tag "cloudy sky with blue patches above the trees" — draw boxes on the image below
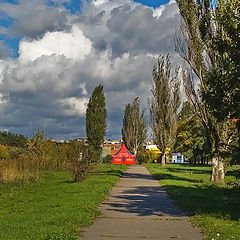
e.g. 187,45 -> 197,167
0,0 -> 179,139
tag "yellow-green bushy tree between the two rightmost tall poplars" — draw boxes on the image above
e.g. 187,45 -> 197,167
174,101 -> 210,161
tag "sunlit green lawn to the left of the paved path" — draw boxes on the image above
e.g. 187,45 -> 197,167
0,165 -> 126,240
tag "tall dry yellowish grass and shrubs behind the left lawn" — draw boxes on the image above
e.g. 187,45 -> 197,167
0,131 -> 90,183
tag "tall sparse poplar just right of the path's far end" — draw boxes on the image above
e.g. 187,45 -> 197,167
149,56 -> 180,165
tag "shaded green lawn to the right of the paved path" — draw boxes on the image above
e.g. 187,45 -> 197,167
146,164 -> 240,240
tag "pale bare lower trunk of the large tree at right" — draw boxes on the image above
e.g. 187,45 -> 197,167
211,157 -> 225,183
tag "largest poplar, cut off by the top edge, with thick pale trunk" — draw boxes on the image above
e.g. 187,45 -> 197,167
176,0 -> 240,182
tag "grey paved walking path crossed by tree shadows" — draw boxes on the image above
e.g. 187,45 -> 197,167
80,166 -> 203,240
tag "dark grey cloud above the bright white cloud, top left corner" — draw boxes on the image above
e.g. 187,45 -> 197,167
0,0 -> 69,38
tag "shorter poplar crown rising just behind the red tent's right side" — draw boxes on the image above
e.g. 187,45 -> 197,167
122,97 -> 147,155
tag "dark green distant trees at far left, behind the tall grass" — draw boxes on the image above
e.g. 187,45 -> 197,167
0,131 -> 27,148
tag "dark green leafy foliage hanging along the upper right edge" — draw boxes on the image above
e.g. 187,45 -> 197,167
201,0 -> 240,121
